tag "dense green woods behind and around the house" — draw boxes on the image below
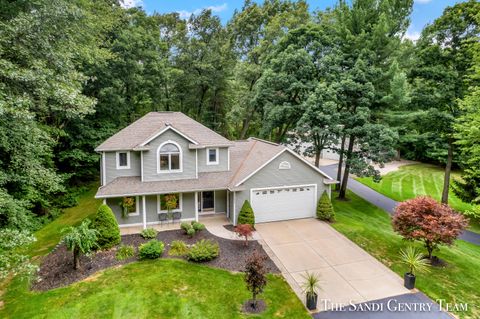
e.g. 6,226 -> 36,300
0,0 -> 480,230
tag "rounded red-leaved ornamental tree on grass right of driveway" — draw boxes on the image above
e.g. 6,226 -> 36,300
392,196 -> 468,259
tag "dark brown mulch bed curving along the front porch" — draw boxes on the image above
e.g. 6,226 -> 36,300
32,229 -> 280,291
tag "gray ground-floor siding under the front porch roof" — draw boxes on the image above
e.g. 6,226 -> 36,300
107,193 -> 195,226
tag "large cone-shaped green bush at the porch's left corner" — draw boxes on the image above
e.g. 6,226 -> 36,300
91,204 -> 120,249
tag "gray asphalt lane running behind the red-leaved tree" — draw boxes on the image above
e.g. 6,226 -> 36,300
320,164 -> 480,246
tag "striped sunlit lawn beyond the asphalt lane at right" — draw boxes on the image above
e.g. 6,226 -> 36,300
357,164 -> 480,233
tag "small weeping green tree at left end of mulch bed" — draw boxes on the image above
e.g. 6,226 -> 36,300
62,219 -> 98,269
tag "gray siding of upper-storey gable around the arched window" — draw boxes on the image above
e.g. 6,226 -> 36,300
143,130 -> 196,182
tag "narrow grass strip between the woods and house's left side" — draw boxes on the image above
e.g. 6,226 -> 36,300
27,183 -> 102,257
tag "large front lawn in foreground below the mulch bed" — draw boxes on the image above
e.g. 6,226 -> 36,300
0,259 -> 309,319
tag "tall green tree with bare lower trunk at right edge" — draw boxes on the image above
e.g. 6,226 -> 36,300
412,0 -> 480,203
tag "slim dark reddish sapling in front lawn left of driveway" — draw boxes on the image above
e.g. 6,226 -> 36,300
245,251 -> 267,309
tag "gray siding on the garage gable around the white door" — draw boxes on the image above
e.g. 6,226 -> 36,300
232,152 -> 330,225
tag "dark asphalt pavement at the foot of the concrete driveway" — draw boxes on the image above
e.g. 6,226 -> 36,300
312,292 -> 453,319
